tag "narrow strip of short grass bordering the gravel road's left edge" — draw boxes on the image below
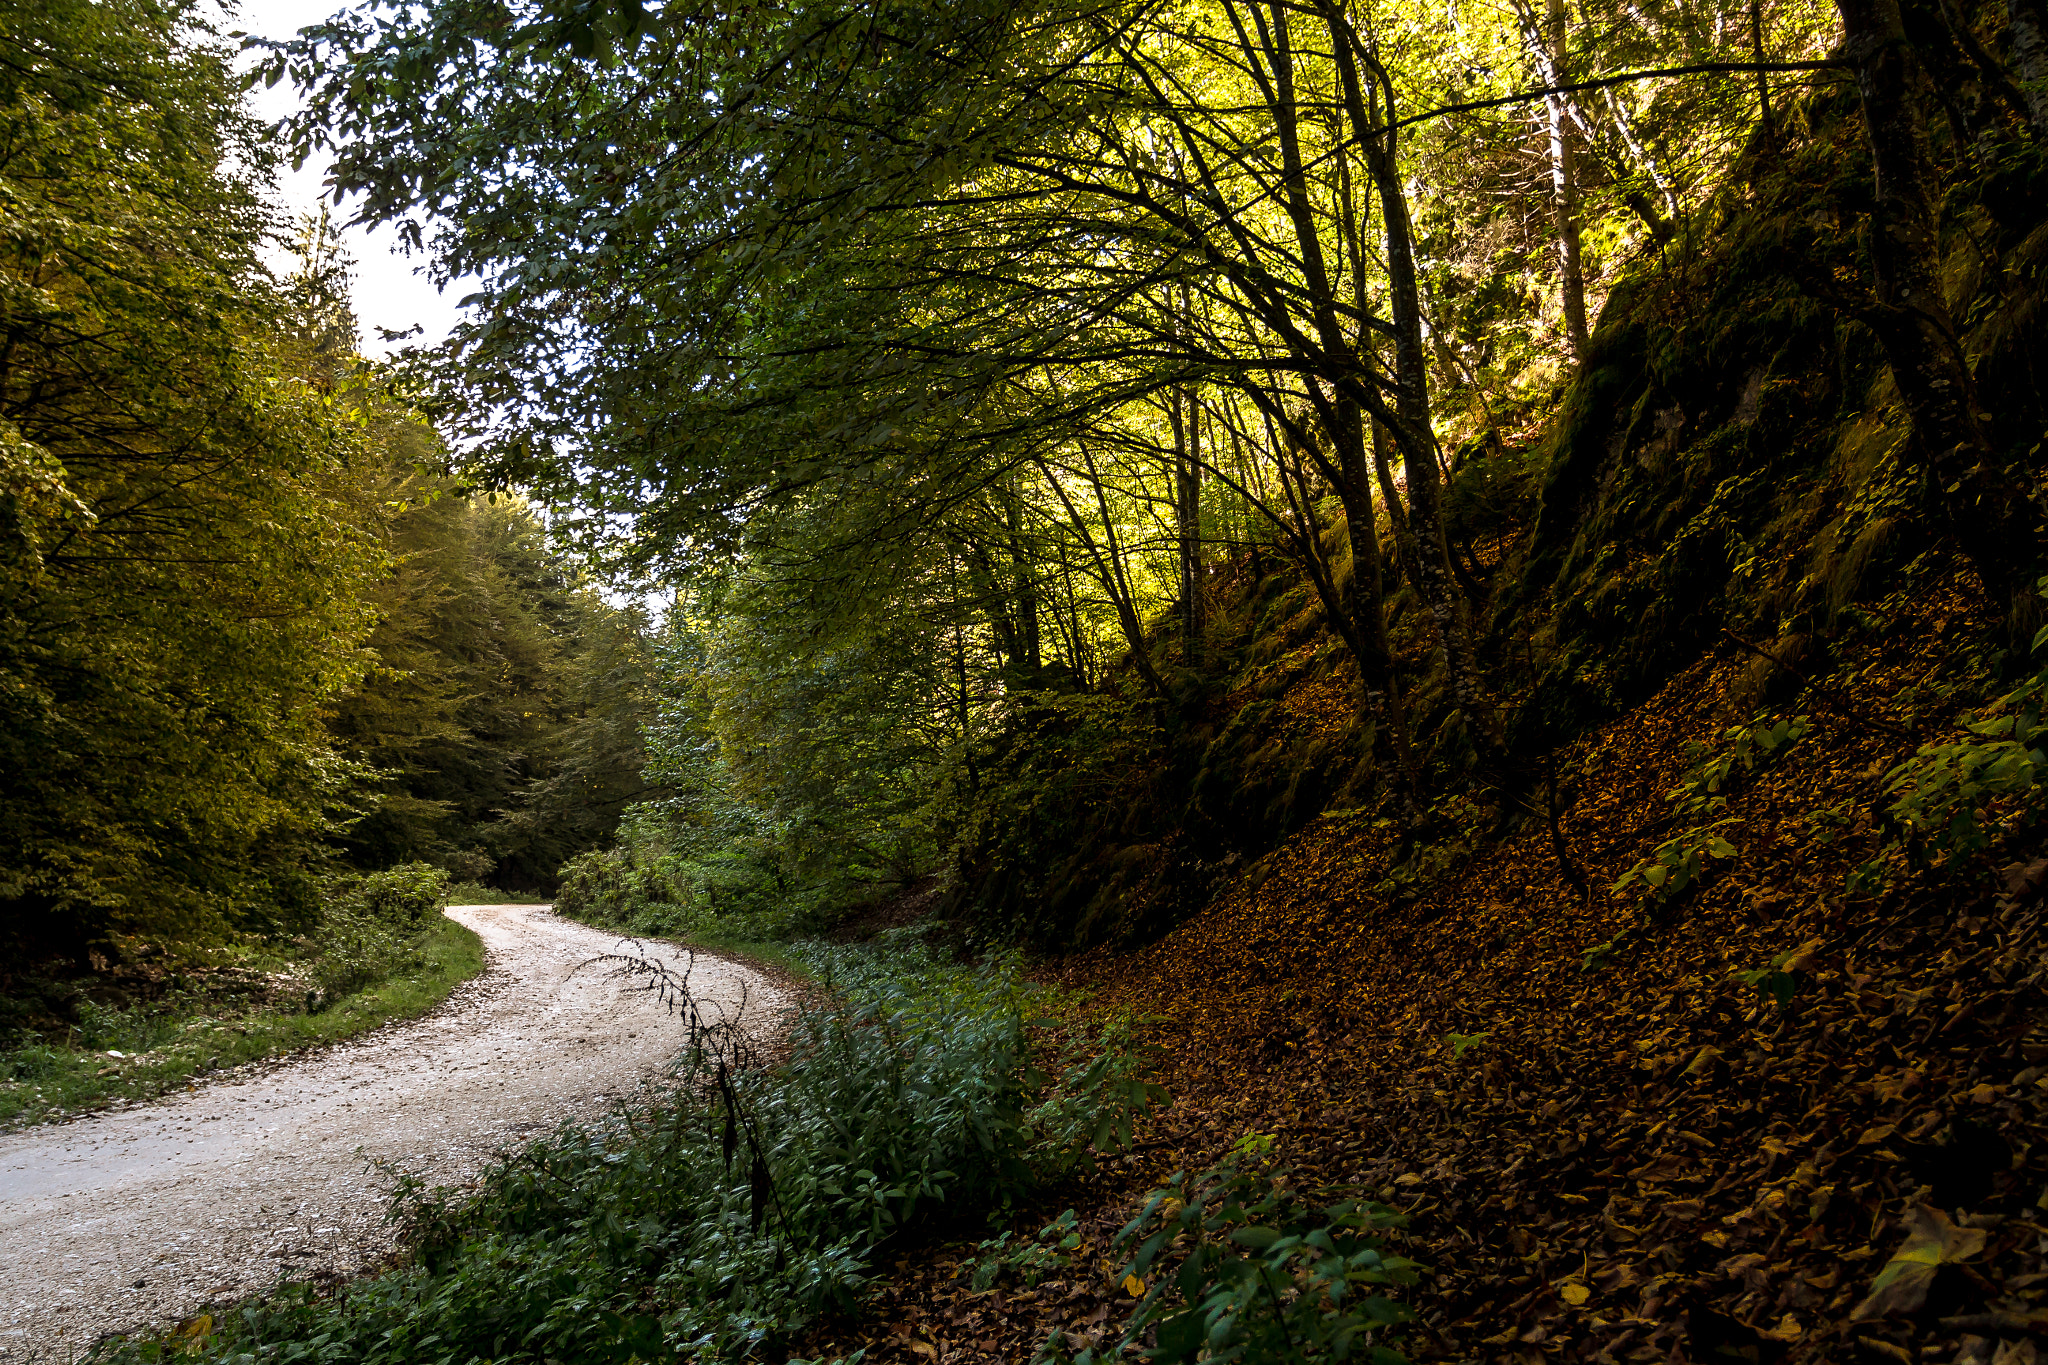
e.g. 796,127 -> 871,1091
0,919 -> 483,1130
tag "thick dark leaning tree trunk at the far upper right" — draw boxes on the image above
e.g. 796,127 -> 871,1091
1837,0 -> 2038,628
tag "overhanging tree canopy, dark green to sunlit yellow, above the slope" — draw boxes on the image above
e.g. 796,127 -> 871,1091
270,0 -> 1859,802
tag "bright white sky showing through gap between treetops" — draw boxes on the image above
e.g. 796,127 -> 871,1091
225,0 -> 469,356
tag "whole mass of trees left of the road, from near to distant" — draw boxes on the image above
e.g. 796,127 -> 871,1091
0,21 -> 655,965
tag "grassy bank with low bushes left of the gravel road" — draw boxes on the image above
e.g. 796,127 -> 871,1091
0,866 -> 483,1128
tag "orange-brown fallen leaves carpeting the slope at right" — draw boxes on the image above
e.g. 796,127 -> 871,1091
815,556 -> 2048,1365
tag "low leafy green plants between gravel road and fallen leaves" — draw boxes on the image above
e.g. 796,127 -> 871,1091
108,941 -> 1171,1361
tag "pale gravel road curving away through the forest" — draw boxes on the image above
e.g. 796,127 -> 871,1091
0,905 -> 782,1365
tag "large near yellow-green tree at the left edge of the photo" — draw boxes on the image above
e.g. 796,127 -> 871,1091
0,0 -> 383,960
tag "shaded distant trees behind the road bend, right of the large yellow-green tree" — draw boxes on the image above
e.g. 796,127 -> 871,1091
330,485 -> 653,888
